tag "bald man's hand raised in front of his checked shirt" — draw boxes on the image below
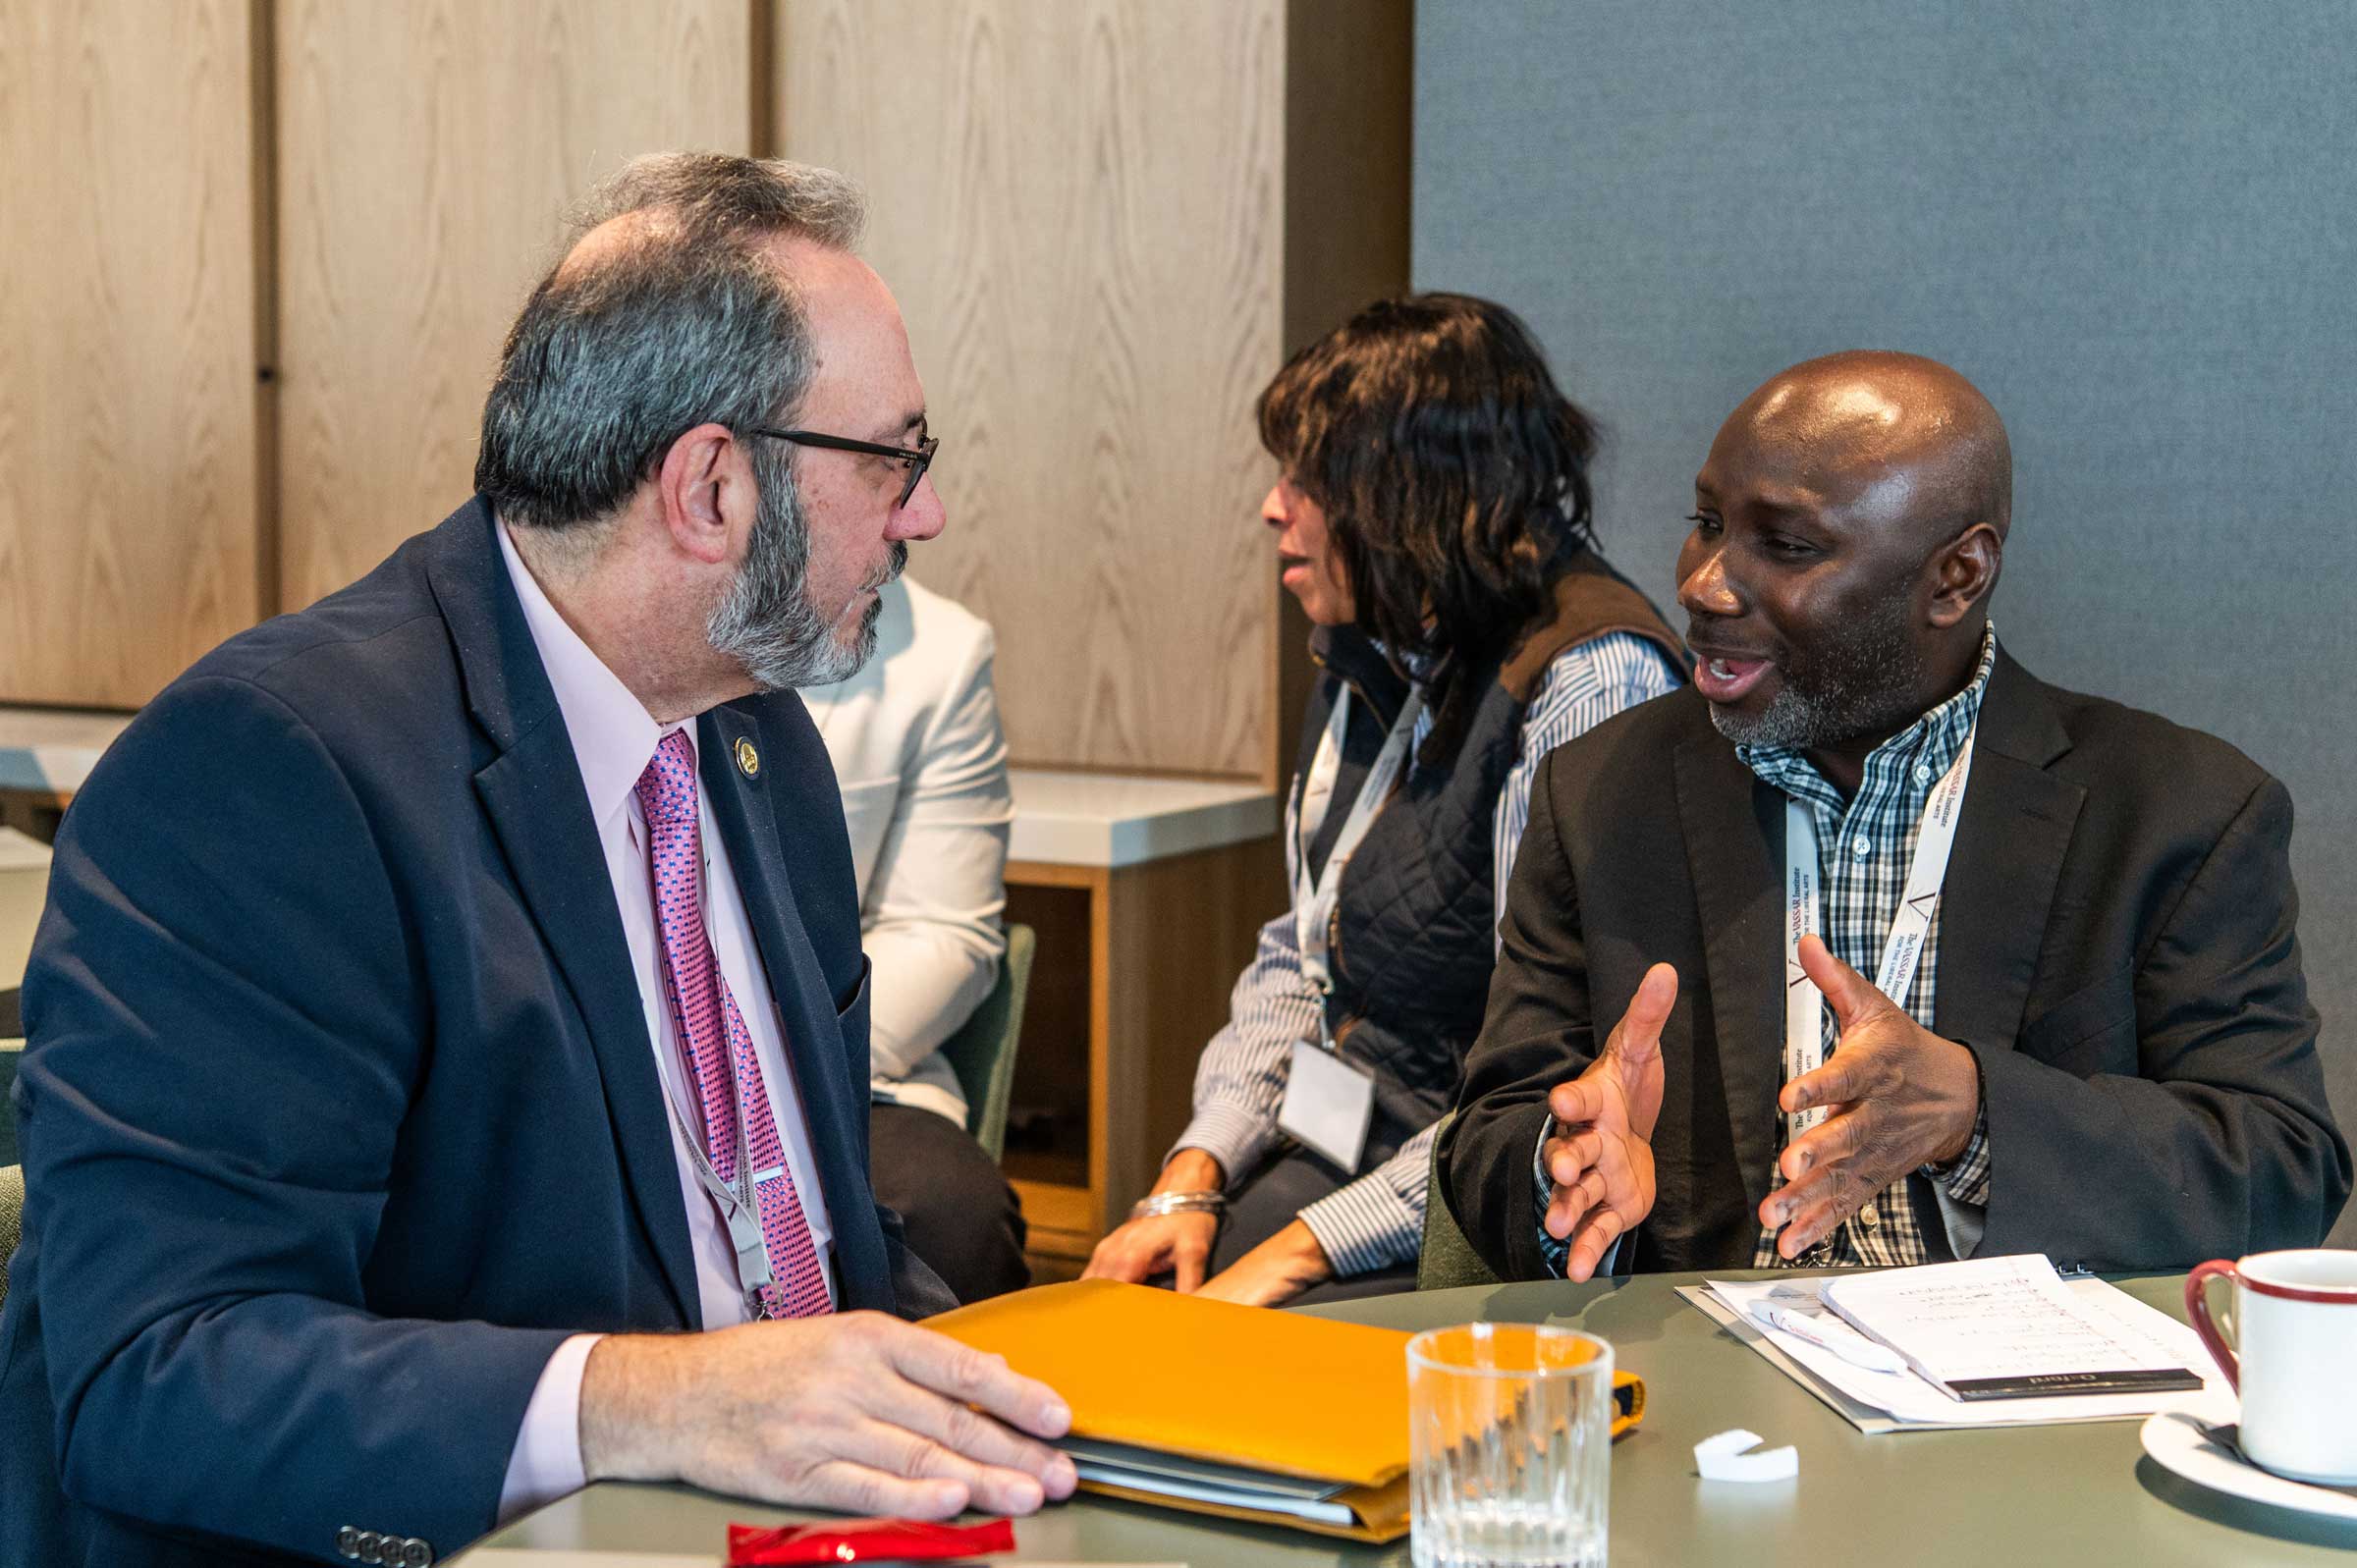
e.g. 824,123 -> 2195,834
1761,936 -> 1980,1257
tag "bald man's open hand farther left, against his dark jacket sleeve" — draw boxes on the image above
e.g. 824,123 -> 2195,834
1542,964 -> 1678,1280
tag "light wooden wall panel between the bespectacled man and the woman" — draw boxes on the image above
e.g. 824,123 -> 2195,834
776,0 -> 1285,778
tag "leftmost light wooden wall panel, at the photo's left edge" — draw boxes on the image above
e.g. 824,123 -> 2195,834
0,0 -> 257,707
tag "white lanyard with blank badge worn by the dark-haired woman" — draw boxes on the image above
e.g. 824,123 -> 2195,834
1278,686 -> 1424,1172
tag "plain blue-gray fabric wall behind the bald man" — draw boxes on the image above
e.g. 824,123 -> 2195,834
1414,0 -> 2357,1245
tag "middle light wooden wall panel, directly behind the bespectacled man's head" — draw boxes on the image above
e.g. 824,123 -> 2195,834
276,0 -> 756,609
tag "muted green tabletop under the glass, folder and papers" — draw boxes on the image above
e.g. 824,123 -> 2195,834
455,1275 -> 2357,1568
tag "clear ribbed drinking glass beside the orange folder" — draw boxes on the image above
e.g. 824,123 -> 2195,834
1407,1323 -> 1613,1568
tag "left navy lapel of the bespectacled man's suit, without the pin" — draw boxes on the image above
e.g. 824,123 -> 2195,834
426,495 -> 702,1327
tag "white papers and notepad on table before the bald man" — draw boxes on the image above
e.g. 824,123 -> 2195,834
1678,1255 -> 2234,1432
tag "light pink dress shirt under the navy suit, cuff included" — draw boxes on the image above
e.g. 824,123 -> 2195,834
500,523 -> 837,1523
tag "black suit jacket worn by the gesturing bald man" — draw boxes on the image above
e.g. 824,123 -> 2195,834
1440,651 -> 2350,1278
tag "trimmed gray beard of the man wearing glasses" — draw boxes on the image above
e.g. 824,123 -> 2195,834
705,474 -> 907,691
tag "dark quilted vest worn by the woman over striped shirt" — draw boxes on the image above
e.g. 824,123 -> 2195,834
1294,552 -> 1685,1167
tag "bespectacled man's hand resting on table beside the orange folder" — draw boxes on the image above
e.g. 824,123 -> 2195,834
579,1311 -> 1077,1519
